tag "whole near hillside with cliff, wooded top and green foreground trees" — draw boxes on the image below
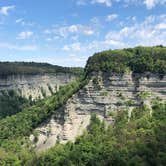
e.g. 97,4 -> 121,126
0,47 -> 166,166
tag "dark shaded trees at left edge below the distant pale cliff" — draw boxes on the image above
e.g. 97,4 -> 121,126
0,90 -> 34,119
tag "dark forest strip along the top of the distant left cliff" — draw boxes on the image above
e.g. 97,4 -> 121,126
0,62 -> 83,77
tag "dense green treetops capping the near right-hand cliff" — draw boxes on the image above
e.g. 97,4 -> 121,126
85,46 -> 166,74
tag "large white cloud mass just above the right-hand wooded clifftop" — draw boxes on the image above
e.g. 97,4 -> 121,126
105,16 -> 166,47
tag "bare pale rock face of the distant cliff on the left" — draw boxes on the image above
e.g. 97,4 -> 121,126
0,73 -> 76,99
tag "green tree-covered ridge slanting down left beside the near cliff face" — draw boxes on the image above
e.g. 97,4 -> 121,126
0,76 -> 86,144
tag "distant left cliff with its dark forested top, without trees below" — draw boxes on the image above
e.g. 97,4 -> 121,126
0,62 -> 82,99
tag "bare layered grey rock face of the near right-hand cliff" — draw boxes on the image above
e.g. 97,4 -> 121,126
30,73 -> 166,151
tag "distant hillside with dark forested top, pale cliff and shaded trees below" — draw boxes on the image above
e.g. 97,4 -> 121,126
0,62 -> 83,119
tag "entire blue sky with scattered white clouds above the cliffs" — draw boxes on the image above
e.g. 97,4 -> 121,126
0,0 -> 166,67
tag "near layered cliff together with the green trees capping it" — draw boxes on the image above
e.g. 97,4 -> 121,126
31,47 -> 166,151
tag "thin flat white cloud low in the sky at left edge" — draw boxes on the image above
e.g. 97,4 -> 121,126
0,43 -> 37,51
